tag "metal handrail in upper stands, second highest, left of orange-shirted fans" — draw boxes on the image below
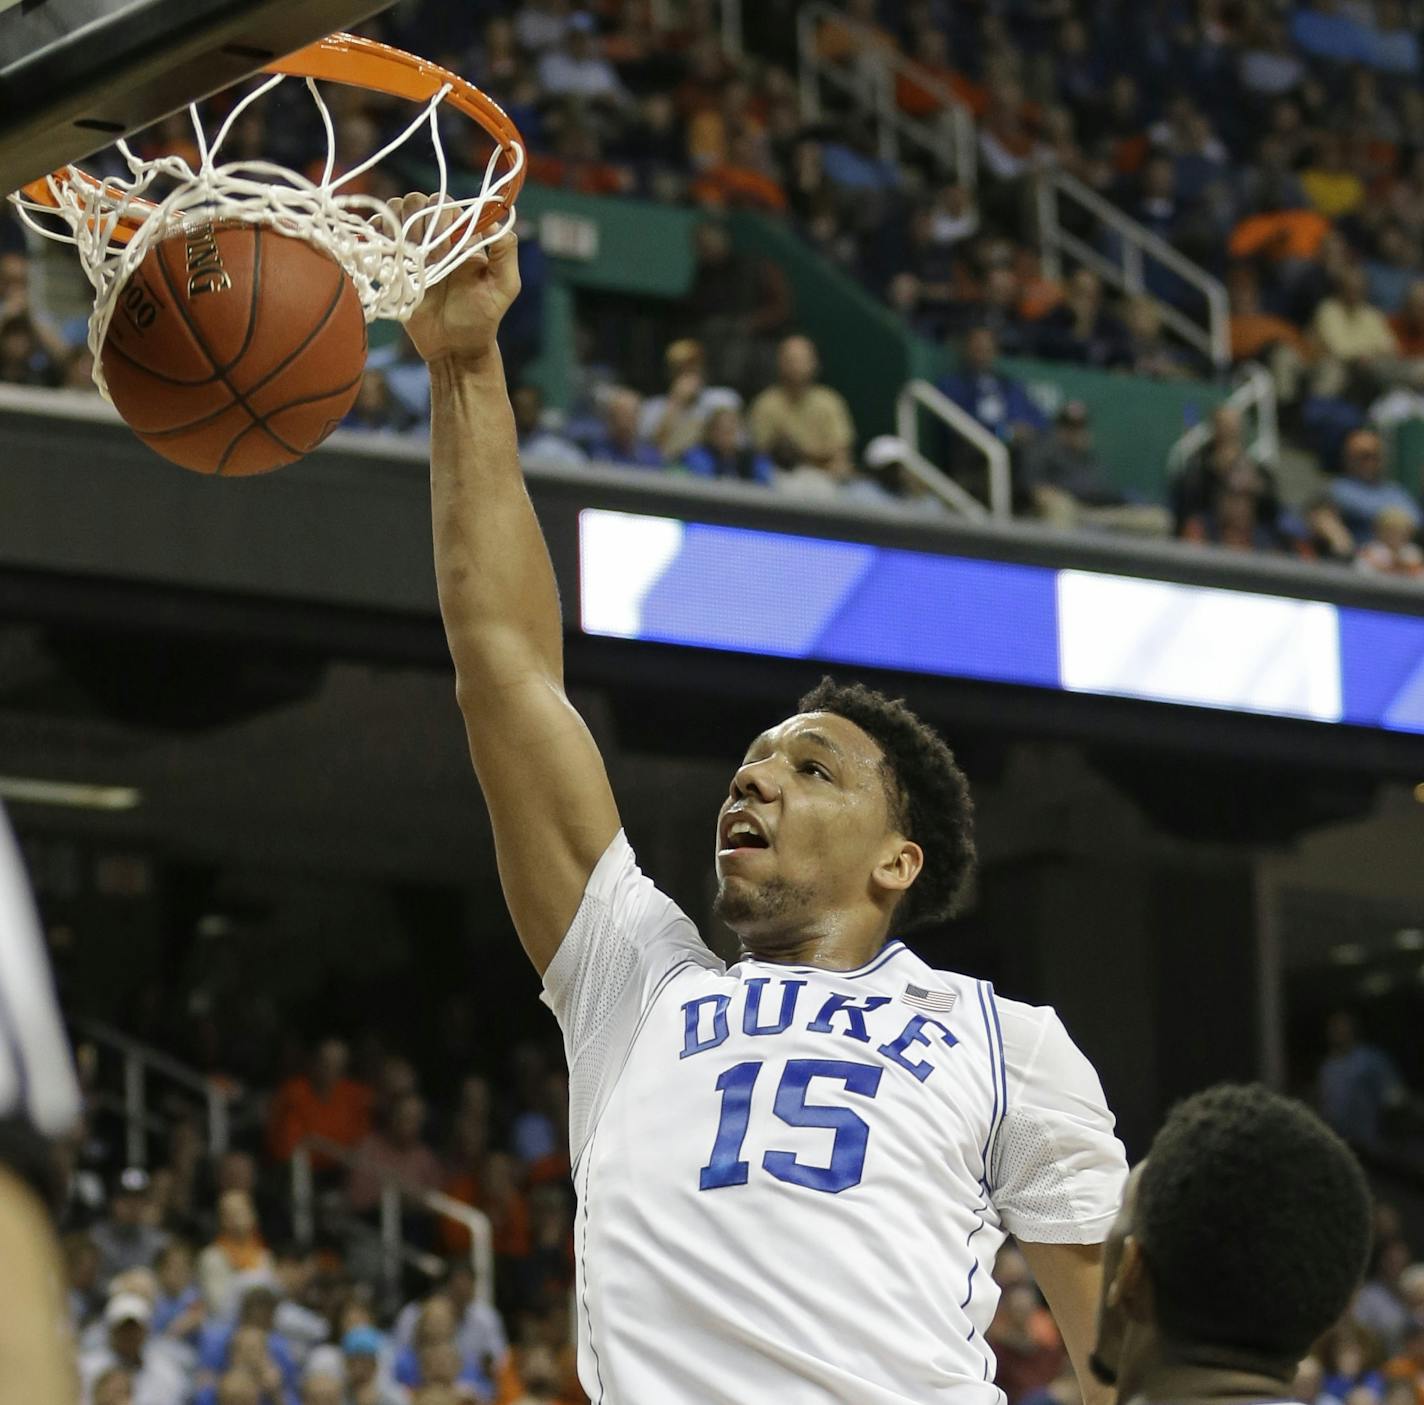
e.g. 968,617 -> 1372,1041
1037,169 -> 1232,370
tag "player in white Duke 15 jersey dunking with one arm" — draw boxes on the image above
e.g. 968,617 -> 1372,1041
402,196 -> 1126,1405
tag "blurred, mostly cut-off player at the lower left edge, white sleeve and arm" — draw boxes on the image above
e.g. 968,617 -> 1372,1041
0,810 -> 80,1405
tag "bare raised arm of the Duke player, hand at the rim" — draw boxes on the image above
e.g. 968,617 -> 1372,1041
404,196 -> 618,974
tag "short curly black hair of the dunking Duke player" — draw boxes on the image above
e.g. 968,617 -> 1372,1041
797,676 -> 974,932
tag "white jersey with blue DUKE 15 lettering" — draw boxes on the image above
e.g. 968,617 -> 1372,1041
544,833 -> 1126,1405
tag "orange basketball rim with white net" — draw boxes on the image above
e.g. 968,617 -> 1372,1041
2,34 -> 525,393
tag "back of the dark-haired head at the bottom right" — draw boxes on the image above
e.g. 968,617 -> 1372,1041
1092,1085 -> 1371,1401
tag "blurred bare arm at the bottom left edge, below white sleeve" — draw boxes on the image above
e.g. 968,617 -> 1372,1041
0,1167 -> 78,1405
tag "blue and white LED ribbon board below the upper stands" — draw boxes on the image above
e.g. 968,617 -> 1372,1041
578,508 -> 1424,732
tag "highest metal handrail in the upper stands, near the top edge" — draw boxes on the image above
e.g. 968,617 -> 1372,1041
796,0 -> 978,188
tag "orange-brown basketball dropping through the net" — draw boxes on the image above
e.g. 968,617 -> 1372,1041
101,222 -> 366,477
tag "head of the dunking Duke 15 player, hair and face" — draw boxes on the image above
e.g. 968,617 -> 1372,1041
716,678 -> 974,957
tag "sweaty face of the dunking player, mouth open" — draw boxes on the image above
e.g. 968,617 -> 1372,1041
716,712 -> 903,951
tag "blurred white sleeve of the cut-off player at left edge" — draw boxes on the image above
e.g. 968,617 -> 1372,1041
0,810 -> 80,1136
